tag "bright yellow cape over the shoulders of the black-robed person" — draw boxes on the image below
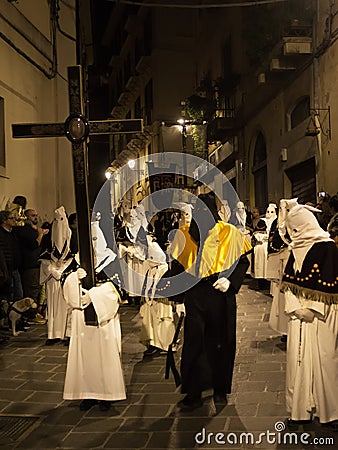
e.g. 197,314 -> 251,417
170,221 -> 252,278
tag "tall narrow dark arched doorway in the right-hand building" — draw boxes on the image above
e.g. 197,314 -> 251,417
252,132 -> 268,212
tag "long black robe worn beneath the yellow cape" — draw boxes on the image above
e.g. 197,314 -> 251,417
181,256 -> 249,396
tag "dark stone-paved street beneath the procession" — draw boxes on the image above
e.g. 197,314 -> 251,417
0,281 -> 338,450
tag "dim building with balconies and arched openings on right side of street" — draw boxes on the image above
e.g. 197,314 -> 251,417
191,0 -> 338,212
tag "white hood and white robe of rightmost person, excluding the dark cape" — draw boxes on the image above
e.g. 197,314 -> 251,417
281,199 -> 338,423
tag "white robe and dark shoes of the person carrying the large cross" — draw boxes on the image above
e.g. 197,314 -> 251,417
63,268 -> 126,411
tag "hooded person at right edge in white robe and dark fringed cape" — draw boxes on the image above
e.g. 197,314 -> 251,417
280,199 -> 338,429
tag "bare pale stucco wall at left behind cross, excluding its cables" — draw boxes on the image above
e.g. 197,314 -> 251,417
0,0 -> 75,220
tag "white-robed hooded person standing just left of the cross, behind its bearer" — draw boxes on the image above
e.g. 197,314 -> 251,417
40,206 -> 74,345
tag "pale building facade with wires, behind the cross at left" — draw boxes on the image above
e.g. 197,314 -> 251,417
0,0 -> 76,220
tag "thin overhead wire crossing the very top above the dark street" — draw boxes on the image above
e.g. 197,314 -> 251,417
108,0 -> 288,9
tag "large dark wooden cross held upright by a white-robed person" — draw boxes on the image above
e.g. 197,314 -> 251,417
12,65 -> 143,325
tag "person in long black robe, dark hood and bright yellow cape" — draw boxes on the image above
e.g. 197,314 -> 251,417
167,192 -> 251,410
